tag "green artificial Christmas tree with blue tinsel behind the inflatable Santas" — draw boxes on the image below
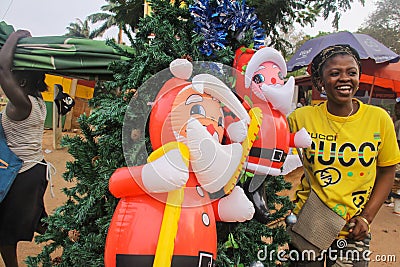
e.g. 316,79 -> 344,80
27,0 -> 291,267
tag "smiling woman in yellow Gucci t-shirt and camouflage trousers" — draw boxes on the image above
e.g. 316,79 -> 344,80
288,45 -> 400,266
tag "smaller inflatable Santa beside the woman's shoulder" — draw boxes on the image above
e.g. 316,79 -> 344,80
237,47 -> 311,223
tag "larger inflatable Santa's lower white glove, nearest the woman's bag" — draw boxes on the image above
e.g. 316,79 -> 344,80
218,186 -> 255,222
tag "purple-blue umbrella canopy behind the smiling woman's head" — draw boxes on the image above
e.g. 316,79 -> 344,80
287,31 -> 400,71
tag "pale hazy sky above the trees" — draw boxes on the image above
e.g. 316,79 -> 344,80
0,0 -> 375,38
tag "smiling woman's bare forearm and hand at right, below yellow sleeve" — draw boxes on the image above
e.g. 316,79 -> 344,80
350,165 -> 396,240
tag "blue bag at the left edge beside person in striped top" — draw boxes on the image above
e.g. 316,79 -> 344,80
0,113 -> 23,202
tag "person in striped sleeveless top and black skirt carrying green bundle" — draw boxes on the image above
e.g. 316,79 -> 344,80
0,30 -> 48,267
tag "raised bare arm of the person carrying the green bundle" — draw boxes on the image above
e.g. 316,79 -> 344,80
0,30 -> 32,121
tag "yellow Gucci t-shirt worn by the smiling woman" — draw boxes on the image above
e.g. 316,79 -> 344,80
288,100 -> 400,221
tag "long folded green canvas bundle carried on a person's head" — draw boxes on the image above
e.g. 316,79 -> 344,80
0,21 -> 134,80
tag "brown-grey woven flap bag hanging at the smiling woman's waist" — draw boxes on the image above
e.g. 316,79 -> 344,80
286,189 -> 346,256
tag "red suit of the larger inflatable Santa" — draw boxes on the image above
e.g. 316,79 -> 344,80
105,167 -> 217,266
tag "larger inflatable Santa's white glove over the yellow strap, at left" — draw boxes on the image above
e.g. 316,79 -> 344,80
142,148 -> 189,193
